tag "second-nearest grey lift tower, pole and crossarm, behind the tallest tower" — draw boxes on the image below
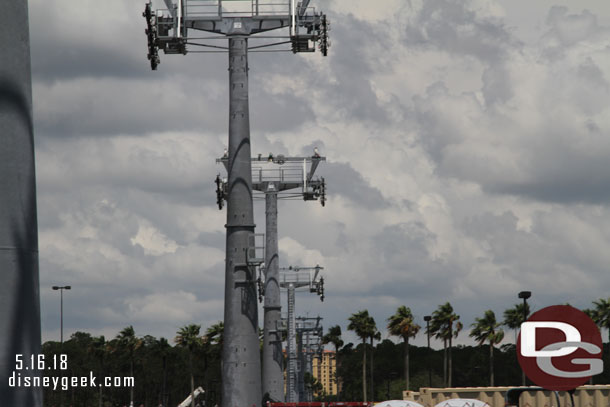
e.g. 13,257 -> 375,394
216,148 -> 326,401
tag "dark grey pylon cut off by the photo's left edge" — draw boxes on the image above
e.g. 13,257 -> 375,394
0,0 -> 42,407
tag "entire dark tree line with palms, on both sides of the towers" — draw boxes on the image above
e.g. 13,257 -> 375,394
42,298 -> 610,407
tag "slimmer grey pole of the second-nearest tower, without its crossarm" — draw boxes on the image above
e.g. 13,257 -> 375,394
263,188 -> 284,401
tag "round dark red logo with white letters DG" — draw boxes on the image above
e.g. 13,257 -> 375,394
517,305 -> 604,390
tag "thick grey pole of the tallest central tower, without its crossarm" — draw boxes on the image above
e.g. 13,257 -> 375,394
222,36 -> 261,407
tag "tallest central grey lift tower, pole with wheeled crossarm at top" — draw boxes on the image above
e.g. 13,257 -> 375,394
144,0 -> 329,407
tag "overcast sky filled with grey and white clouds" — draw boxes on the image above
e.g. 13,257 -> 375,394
29,0 -> 610,346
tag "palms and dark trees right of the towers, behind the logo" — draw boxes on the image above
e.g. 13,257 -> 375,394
323,298 -> 610,401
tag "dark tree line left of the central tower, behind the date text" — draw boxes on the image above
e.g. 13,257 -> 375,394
42,322 -> 224,407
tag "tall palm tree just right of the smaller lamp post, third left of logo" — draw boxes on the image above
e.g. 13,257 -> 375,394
430,302 -> 463,387
